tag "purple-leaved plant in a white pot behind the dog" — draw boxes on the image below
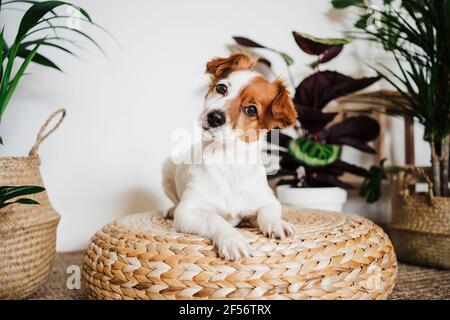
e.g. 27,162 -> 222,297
234,32 -> 379,211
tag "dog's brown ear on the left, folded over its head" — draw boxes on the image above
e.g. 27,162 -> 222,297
206,52 -> 257,78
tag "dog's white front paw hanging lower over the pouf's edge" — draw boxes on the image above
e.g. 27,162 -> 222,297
216,232 -> 250,260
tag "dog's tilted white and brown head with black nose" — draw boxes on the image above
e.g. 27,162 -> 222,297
199,52 -> 297,142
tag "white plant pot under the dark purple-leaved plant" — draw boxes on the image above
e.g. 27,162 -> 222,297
276,185 -> 347,212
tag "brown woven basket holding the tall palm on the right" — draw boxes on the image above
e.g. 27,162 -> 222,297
389,194 -> 450,269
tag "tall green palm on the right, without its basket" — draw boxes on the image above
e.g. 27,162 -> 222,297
331,0 -> 450,197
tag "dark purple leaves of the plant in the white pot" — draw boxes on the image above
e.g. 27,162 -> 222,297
233,32 -> 380,189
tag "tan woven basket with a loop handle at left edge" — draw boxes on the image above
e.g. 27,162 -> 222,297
0,110 -> 65,299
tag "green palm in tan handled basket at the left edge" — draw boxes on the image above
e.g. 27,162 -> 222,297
0,0 -> 102,299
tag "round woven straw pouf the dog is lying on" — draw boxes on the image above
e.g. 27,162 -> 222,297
82,208 -> 397,299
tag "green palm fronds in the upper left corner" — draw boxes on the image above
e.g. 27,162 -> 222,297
0,0 -> 102,143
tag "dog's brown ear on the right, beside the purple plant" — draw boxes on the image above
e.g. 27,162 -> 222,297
268,79 -> 297,129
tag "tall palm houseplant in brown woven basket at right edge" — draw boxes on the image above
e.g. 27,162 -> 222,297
332,0 -> 450,268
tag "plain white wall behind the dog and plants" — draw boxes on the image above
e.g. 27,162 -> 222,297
0,0 -> 426,251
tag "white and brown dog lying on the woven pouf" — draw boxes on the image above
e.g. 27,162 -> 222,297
162,52 -> 297,260
